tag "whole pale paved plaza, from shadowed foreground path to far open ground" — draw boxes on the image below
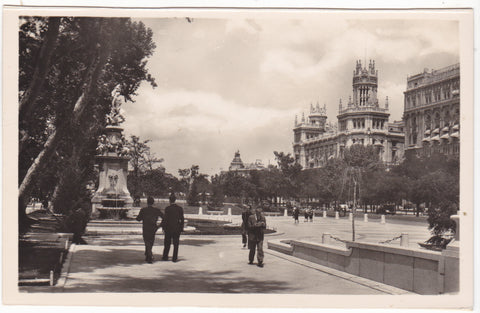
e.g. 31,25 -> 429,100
47,215 -> 429,295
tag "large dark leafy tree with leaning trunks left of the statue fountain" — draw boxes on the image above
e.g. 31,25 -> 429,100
19,17 -> 155,225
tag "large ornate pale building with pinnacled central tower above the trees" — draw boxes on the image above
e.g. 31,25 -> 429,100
293,61 -> 405,168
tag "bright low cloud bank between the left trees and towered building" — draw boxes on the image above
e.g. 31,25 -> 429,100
125,90 -> 295,174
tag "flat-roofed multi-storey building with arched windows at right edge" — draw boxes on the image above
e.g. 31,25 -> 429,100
403,64 -> 460,156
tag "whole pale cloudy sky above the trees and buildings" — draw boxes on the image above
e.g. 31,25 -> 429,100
124,14 -> 459,175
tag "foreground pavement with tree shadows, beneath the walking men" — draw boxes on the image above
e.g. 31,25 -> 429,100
60,235 -> 388,295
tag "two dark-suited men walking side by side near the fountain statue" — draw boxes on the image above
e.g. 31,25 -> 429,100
137,193 -> 185,263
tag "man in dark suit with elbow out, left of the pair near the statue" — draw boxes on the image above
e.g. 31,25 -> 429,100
137,197 -> 163,263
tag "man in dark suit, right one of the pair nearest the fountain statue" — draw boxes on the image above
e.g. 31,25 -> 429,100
162,193 -> 185,262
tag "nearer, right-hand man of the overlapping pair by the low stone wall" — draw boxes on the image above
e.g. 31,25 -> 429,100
248,207 -> 267,267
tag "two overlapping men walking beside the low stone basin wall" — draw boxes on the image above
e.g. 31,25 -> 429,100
242,206 -> 267,267
